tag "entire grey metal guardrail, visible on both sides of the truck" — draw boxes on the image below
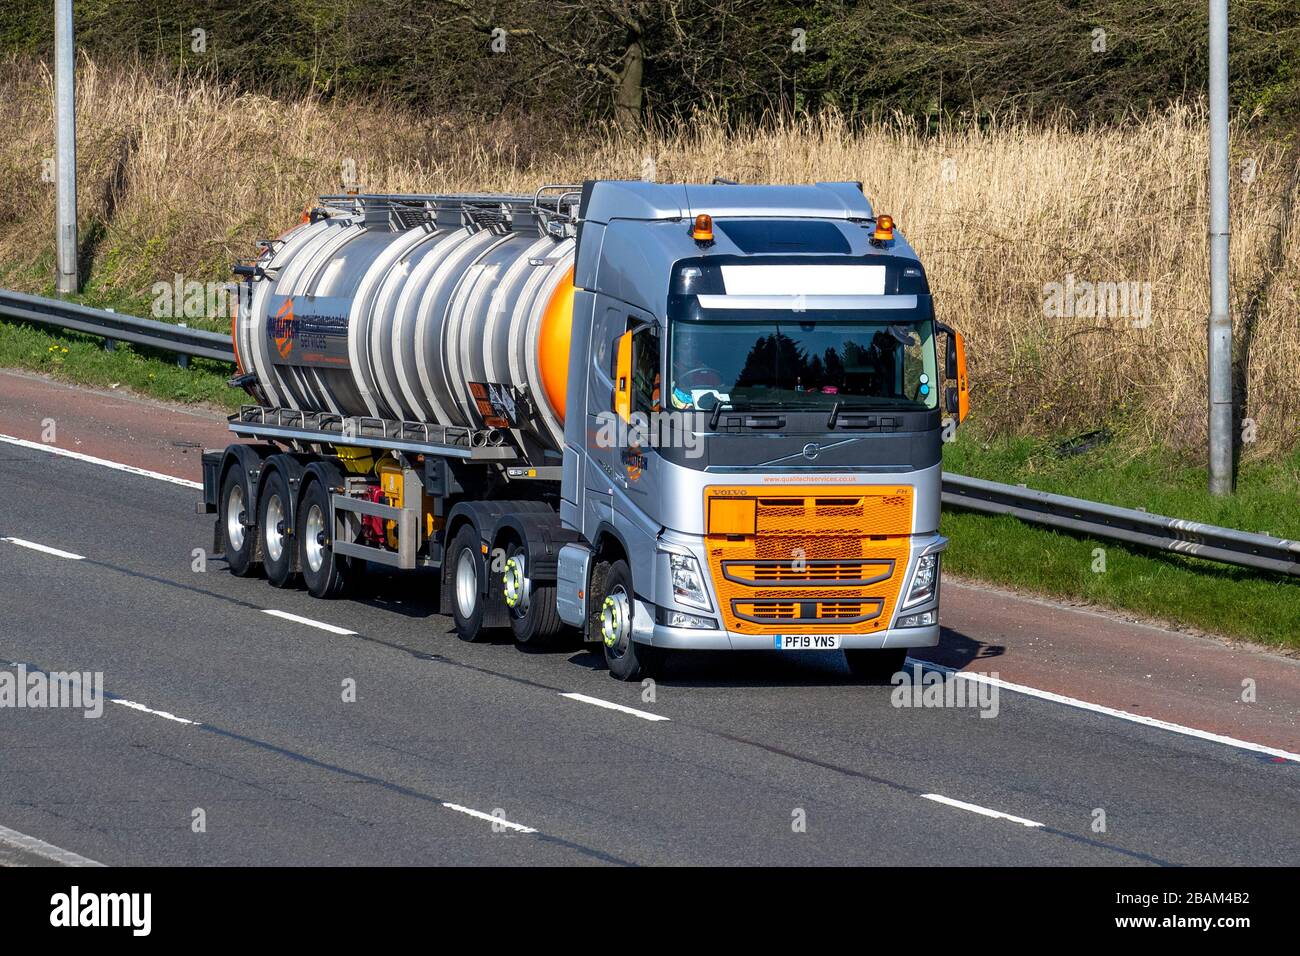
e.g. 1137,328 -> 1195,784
0,289 -> 1300,576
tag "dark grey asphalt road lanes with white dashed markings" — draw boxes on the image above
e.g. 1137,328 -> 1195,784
0,445 -> 1300,865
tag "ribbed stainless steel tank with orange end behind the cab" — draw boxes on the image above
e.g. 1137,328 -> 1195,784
234,187 -> 577,449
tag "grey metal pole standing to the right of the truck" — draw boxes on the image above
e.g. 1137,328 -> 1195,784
1209,0 -> 1232,496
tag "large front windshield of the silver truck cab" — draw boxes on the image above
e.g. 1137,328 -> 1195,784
670,310 -> 939,411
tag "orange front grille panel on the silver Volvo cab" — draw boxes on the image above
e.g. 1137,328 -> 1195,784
705,485 -> 913,633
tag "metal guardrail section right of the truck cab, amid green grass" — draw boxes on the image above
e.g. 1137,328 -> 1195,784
944,473 -> 1300,576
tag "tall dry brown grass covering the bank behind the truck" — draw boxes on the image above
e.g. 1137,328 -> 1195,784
0,55 -> 1300,455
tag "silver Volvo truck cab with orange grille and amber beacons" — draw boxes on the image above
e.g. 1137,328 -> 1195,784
556,181 -> 966,679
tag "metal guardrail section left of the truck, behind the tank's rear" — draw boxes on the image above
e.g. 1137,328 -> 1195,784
0,289 -> 235,363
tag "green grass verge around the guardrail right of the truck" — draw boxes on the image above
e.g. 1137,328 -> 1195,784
943,434 -> 1300,649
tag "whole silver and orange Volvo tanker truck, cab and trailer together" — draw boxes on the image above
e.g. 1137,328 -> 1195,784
202,181 -> 967,680
